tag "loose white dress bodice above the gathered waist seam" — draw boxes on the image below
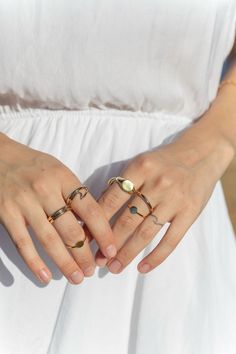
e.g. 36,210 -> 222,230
0,0 -> 236,119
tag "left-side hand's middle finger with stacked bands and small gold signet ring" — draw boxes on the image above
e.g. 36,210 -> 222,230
43,195 -> 95,276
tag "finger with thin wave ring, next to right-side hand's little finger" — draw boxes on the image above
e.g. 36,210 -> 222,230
107,205 -> 173,273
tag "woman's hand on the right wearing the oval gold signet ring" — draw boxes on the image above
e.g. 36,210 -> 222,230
96,127 -> 233,273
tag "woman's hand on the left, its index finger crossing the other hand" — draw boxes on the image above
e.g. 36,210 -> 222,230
0,133 -> 116,284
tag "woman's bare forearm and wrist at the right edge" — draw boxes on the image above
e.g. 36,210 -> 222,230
170,60 -> 236,178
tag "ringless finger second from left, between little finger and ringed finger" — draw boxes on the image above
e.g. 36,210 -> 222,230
24,203 -> 84,284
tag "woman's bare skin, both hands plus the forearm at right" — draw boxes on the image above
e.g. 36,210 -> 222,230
0,42 -> 236,284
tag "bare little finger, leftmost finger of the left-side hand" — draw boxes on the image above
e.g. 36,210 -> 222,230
2,210 -> 52,284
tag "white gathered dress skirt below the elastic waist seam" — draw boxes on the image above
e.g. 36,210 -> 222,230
0,109 -> 236,354
